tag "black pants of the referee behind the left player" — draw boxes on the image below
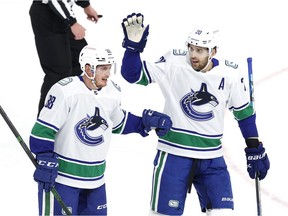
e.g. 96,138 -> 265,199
29,1 -> 87,115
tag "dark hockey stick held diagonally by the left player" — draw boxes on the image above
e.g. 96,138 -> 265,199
0,105 -> 72,215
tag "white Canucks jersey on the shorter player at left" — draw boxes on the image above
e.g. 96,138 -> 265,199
30,76 -> 126,188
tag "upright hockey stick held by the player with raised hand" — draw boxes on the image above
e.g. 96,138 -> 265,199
247,57 -> 262,216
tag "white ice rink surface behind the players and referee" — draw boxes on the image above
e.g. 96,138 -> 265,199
0,0 -> 288,216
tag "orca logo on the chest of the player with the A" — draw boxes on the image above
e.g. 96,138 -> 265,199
180,83 -> 219,121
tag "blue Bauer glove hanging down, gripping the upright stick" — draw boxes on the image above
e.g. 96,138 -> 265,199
245,142 -> 270,180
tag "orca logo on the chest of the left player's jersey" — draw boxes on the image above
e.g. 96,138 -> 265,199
74,107 -> 109,146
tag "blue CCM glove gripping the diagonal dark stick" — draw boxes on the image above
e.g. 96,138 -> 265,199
33,152 -> 58,192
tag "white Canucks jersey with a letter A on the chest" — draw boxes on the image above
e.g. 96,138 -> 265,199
137,50 -> 254,159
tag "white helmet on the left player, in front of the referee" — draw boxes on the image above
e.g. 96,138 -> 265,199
79,45 -> 115,78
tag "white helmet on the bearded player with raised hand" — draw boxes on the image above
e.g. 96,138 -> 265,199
186,27 -> 218,51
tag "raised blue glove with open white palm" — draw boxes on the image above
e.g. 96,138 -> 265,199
121,13 -> 149,52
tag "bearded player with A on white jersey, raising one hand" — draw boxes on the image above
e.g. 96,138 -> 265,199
121,13 -> 270,216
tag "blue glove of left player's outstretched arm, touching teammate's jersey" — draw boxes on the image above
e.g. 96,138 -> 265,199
142,109 -> 172,136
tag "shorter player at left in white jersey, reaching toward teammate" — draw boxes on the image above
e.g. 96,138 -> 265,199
30,45 -> 172,215
